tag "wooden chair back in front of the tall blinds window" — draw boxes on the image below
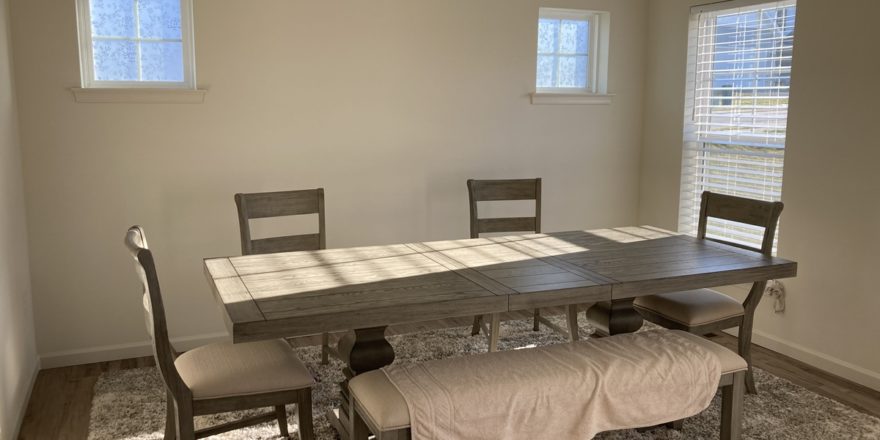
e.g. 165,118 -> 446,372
697,191 -> 784,255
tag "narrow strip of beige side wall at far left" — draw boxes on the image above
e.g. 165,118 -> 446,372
0,0 -> 39,440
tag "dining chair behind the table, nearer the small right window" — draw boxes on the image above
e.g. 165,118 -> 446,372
467,178 -> 578,351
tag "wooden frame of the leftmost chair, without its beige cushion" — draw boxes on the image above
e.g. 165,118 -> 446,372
125,226 -> 314,440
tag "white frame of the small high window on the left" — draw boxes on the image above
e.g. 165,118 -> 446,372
76,0 -> 196,90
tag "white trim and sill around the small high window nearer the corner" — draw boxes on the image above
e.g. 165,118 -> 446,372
530,8 -> 614,104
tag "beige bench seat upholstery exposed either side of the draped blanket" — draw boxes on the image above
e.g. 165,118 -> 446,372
348,330 -> 748,440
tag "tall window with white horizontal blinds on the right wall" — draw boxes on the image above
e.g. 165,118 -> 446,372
679,1 -> 795,252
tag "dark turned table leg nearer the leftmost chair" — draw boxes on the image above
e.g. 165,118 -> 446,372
327,326 -> 394,440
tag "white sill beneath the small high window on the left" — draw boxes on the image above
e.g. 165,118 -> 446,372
70,87 -> 208,104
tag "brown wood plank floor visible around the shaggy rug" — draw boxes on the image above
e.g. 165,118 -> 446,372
19,310 -> 880,440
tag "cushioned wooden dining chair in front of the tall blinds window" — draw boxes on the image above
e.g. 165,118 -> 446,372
633,191 -> 783,394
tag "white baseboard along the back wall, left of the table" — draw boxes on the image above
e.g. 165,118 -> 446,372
40,332 -> 229,368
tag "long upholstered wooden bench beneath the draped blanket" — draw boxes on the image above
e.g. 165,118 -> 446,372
349,330 -> 748,440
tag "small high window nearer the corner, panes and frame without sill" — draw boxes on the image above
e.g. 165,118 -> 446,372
536,8 -> 609,93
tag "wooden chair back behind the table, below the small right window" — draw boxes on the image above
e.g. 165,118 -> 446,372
467,178 -> 541,238
